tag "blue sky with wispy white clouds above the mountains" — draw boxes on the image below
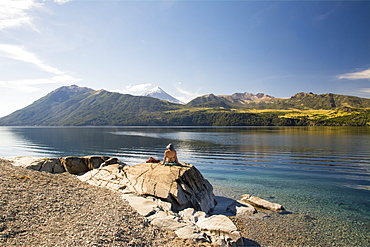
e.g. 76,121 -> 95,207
0,0 -> 370,117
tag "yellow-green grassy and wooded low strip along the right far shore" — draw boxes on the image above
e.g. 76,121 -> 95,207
161,107 -> 370,126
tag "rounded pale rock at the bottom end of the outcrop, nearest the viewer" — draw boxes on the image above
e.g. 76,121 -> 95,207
196,215 -> 243,246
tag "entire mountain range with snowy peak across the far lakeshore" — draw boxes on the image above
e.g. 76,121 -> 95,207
0,85 -> 370,126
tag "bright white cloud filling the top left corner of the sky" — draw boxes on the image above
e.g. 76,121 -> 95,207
0,0 -> 43,30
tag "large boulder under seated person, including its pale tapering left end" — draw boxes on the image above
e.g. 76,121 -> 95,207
78,163 -> 216,213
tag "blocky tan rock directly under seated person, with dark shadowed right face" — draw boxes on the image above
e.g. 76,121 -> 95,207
123,163 -> 216,213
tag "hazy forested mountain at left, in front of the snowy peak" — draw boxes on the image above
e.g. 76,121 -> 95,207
0,87 -> 178,126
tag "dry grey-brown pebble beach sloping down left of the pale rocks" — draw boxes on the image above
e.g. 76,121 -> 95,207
0,159 -> 193,247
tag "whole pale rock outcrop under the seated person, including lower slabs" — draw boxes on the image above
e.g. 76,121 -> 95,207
78,163 -> 243,246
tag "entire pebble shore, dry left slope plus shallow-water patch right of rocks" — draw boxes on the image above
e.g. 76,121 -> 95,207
0,159 -> 370,247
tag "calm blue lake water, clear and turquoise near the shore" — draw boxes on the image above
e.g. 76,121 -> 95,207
0,127 -> 370,245
